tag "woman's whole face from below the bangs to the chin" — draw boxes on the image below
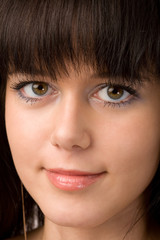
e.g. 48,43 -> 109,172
5,68 -> 160,227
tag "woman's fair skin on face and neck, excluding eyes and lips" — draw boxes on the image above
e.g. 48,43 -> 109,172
5,67 -> 160,240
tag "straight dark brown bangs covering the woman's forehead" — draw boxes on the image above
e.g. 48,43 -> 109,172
0,0 -> 160,81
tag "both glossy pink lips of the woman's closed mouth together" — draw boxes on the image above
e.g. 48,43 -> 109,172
46,169 -> 104,191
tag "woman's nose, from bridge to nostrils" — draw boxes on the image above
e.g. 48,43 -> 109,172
51,96 -> 91,151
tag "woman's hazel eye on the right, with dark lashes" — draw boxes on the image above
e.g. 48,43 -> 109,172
92,86 -> 136,105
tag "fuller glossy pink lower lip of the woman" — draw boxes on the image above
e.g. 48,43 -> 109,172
46,171 -> 103,191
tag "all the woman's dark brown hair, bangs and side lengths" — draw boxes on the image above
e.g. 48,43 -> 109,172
0,0 -> 160,239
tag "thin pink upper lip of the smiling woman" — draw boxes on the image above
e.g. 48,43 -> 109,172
46,168 -> 105,176
